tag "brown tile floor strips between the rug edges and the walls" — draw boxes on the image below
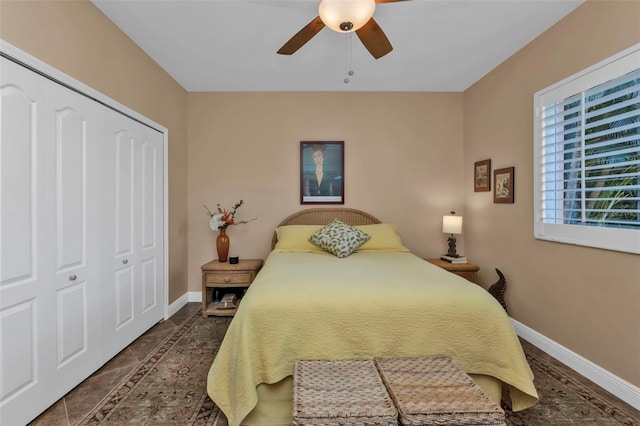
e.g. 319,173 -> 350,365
30,303 -> 637,426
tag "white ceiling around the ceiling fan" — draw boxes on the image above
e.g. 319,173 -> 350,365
92,0 -> 584,92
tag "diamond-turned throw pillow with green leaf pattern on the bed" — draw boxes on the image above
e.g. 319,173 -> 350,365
309,219 -> 371,258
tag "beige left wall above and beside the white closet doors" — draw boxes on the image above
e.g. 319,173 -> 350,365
0,0 -> 187,302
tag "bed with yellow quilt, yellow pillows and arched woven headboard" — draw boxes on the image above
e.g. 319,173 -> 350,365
207,208 -> 538,426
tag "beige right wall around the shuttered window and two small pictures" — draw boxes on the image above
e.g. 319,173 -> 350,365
464,1 -> 640,386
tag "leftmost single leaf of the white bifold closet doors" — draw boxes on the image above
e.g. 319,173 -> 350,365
0,58 -> 55,424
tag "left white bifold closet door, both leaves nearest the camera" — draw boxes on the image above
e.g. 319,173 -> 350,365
0,58 -> 102,424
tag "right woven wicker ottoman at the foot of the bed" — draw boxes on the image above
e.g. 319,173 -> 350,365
375,356 -> 506,426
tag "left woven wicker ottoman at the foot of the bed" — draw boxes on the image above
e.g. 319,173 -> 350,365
293,360 -> 398,426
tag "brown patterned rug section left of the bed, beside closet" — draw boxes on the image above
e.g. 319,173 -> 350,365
79,312 -> 230,426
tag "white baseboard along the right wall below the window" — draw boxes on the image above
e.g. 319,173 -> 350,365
511,318 -> 640,410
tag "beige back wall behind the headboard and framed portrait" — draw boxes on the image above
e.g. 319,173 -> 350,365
188,93 -> 463,291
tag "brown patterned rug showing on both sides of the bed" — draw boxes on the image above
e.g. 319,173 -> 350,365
79,312 -> 640,426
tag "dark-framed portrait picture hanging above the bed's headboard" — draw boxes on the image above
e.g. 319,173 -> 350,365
300,141 -> 344,204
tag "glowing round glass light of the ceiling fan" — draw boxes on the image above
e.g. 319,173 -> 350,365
318,0 -> 376,33
